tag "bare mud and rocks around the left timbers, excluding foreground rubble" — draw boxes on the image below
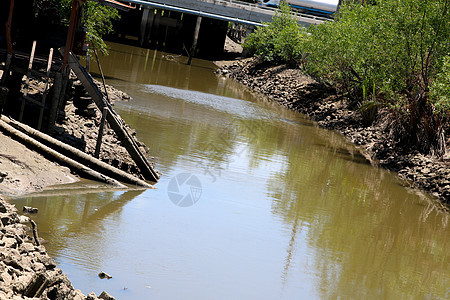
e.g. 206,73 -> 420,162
0,77 -> 149,197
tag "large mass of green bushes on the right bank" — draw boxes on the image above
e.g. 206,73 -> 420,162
303,0 -> 450,153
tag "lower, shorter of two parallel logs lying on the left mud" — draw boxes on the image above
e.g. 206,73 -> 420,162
0,116 -> 126,188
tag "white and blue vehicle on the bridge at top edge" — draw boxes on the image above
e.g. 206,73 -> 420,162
258,0 -> 341,18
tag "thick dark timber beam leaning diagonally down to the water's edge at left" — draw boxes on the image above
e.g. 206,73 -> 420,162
68,53 -> 159,182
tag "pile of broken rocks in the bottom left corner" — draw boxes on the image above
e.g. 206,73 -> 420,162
0,195 -> 114,300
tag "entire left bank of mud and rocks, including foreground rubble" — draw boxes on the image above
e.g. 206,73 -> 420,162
0,77 -> 148,300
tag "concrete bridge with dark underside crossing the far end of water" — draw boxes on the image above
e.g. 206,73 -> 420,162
110,0 -> 326,58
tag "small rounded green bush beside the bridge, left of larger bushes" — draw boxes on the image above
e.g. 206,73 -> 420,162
243,1 -> 304,63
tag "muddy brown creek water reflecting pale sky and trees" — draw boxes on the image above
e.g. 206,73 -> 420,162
15,44 -> 450,299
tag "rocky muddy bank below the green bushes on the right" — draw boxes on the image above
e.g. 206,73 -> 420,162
217,59 -> 450,205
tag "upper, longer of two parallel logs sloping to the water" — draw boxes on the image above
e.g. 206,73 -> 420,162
0,116 -> 153,188
